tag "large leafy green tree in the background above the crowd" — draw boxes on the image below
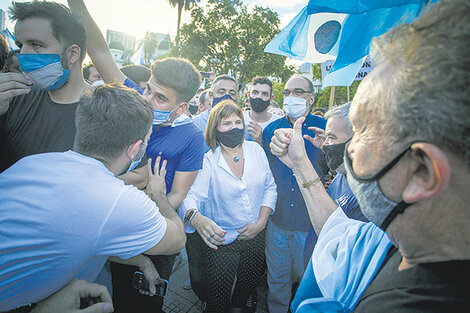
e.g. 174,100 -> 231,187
180,0 -> 294,85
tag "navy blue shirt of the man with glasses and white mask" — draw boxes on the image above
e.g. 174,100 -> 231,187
263,114 -> 328,232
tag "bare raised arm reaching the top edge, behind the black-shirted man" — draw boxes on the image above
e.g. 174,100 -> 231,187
67,0 -> 126,83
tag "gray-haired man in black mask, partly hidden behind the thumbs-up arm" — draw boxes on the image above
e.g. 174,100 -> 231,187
304,103 -> 368,265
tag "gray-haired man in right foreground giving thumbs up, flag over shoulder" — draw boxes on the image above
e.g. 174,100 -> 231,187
271,0 -> 470,312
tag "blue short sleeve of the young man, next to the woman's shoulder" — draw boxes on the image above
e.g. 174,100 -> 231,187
175,131 -> 204,172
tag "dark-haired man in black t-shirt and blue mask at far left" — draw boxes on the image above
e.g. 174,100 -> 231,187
0,2 -> 91,172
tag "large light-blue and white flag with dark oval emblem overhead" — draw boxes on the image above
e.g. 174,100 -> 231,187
264,0 -> 436,87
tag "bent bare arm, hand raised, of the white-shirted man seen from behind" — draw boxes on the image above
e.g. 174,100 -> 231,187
145,156 -> 186,255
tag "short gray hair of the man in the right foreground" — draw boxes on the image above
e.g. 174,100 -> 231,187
354,0 -> 470,167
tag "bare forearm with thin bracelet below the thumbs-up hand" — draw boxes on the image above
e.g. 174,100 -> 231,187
292,157 -> 338,235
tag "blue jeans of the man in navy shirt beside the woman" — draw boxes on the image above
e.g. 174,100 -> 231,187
266,221 -> 308,313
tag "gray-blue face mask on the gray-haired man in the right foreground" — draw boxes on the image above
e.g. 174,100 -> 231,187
344,146 -> 411,231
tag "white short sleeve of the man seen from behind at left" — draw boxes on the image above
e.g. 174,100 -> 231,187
96,186 -> 167,259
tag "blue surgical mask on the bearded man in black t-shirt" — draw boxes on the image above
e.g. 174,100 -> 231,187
18,53 -> 70,90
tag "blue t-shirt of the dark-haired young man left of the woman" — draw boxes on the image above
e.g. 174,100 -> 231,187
147,123 -> 204,193
